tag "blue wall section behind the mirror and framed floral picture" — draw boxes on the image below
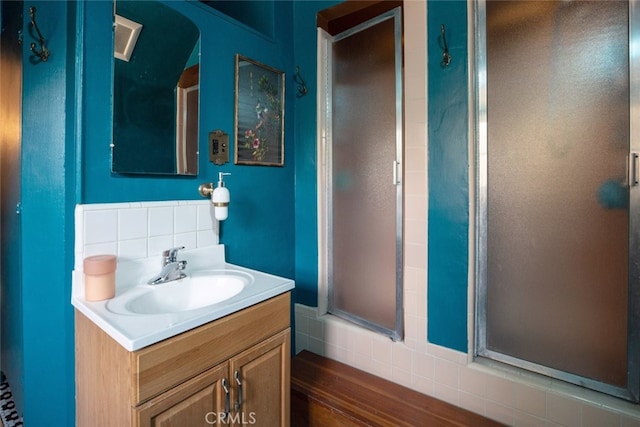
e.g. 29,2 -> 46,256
82,1 -> 296,278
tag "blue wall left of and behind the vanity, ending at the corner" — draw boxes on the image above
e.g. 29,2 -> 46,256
10,0 -> 295,426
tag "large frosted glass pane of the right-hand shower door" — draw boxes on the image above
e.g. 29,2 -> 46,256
478,1 -> 637,402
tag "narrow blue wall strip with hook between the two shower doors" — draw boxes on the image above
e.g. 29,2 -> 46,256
427,0 -> 469,352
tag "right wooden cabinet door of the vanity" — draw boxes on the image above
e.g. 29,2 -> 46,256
229,329 -> 291,427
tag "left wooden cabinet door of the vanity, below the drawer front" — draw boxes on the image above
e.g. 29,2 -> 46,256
134,363 -> 229,427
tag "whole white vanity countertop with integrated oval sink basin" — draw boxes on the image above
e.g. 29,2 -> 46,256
71,245 -> 295,351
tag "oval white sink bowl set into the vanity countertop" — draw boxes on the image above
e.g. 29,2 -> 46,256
106,270 -> 253,315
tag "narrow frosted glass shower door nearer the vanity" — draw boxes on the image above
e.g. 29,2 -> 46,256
325,8 -> 402,339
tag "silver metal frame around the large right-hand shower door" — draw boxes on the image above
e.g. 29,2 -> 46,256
468,0 -> 640,402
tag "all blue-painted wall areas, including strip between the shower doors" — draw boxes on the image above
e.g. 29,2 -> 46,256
7,0 -> 468,426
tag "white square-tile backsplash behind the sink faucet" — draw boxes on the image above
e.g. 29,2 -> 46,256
75,200 -> 218,271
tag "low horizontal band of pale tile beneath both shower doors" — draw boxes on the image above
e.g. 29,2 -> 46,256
295,304 -> 640,427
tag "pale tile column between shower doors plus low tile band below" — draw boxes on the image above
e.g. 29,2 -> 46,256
295,1 -> 640,427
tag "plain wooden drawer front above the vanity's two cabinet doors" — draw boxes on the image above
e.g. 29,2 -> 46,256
131,292 -> 291,406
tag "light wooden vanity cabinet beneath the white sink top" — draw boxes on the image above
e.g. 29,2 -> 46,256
76,293 -> 291,427
